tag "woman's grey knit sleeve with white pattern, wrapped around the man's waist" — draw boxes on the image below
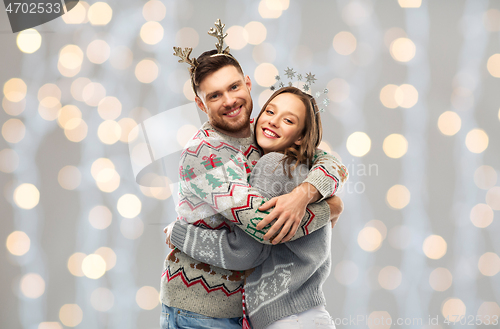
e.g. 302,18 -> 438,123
167,221 -> 272,271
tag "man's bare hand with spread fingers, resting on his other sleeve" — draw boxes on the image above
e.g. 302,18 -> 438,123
257,183 -> 322,244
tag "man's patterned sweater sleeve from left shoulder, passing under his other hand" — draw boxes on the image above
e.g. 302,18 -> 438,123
177,140 -> 330,244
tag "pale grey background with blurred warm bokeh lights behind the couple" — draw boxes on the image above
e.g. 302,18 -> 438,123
0,0 -> 500,329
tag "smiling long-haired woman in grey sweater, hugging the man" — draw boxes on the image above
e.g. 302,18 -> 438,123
166,87 -> 347,329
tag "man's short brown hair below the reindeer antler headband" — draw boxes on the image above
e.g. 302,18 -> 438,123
189,49 -> 243,96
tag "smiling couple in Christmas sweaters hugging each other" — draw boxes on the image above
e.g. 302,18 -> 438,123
160,20 -> 348,329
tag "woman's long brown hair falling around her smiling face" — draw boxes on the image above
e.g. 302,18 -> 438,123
254,87 -> 323,177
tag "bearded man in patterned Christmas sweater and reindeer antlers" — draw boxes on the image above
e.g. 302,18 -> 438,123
161,22 -> 342,328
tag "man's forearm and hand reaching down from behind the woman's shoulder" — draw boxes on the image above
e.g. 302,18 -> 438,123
257,149 -> 349,242
